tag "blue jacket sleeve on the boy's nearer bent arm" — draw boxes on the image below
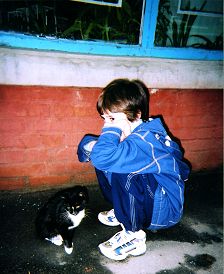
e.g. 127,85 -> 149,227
90,127 -> 157,173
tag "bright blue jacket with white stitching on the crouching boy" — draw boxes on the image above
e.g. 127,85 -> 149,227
90,118 -> 189,230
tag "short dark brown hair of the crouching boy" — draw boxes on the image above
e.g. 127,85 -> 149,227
97,79 -> 149,122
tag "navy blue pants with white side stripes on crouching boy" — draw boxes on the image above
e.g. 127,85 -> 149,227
96,169 -> 158,231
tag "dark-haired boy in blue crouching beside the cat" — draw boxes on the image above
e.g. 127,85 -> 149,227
78,79 -> 189,260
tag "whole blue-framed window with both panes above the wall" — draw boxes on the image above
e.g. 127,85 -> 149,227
0,0 -> 223,60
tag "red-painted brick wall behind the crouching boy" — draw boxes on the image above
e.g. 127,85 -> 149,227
0,85 -> 223,190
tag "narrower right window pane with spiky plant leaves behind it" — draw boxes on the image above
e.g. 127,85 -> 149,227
154,0 -> 223,50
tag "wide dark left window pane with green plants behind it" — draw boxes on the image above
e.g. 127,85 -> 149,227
0,0 -> 144,44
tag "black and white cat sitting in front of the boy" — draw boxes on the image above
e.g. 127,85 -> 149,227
36,186 -> 89,254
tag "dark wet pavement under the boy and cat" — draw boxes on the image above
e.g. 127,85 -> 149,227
0,174 -> 223,274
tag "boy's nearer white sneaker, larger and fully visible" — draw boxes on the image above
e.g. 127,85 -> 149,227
99,227 -> 146,261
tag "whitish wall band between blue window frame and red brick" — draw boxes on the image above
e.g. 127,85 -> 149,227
0,47 -> 223,89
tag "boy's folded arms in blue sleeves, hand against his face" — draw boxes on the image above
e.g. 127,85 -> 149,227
78,113 -> 147,173
